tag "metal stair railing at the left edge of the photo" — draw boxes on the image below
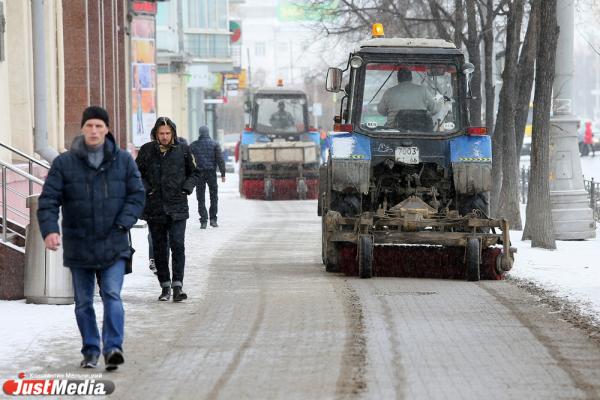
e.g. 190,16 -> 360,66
0,142 -> 50,243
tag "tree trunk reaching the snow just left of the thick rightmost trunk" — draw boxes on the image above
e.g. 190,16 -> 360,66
496,0 -> 525,230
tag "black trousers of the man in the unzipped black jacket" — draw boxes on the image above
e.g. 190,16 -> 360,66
148,218 -> 186,287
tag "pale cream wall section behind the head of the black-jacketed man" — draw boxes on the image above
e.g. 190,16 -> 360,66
157,73 -> 190,142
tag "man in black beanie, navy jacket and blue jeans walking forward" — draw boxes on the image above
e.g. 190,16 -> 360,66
37,106 -> 144,371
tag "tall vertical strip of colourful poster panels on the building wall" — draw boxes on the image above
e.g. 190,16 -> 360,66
131,15 -> 156,147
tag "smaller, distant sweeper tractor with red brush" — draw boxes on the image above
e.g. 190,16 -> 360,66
239,83 -> 320,200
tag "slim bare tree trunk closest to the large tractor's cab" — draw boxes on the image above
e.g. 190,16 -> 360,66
465,0 -> 481,126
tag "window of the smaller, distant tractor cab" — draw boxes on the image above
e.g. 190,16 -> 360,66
255,97 -> 306,133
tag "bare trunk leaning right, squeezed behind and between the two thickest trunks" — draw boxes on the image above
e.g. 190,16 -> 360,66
515,0 -> 540,154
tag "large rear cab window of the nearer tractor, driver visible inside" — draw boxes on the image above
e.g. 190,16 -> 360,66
360,63 -> 459,133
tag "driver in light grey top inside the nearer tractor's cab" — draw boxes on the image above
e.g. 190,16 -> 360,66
377,69 -> 440,131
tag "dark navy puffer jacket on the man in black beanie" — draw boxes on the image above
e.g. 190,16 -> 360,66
37,133 -> 145,269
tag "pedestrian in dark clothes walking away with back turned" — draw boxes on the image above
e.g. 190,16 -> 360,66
190,126 -> 225,229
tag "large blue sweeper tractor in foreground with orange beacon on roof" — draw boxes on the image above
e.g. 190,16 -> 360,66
318,25 -> 516,281
